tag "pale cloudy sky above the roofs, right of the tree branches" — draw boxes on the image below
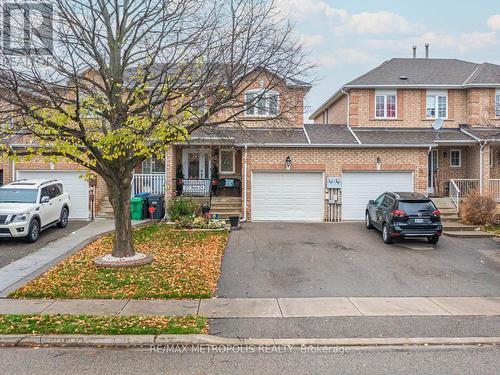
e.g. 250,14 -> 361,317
276,0 -> 500,121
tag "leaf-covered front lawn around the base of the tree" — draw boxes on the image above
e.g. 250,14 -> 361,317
10,223 -> 228,299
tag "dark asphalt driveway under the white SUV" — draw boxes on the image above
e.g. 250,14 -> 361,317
0,220 -> 89,267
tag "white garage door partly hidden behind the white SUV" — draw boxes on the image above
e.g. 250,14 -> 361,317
17,171 -> 89,219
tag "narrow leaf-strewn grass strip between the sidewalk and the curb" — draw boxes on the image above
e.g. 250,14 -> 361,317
0,314 -> 207,335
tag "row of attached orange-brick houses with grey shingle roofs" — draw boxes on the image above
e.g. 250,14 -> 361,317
3,54 -> 500,222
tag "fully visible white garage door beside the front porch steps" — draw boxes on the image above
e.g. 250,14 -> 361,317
251,172 -> 324,222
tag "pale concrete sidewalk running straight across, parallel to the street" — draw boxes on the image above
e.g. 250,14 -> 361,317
0,297 -> 500,318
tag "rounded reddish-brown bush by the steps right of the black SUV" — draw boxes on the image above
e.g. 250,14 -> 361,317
460,192 -> 496,225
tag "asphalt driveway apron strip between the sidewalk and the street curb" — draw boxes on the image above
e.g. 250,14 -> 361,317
209,316 -> 500,338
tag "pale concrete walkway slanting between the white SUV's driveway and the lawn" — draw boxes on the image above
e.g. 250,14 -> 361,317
0,220 -> 144,297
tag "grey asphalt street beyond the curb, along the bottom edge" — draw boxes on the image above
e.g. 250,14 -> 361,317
0,347 -> 500,375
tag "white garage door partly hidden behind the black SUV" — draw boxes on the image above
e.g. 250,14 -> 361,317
342,172 -> 413,220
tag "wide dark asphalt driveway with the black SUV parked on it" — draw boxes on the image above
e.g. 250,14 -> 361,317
217,223 -> 500,297
